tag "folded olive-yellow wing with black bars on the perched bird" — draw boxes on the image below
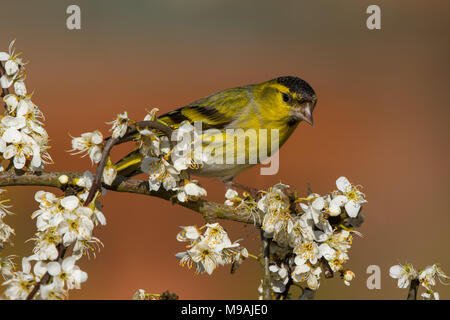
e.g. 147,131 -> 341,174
158,87 -> 250,130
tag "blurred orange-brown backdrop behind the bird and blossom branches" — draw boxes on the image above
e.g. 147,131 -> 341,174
0,0 -> 450,299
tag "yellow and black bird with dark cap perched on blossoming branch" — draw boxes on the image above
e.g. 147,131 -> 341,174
116,76 -> 317,181
